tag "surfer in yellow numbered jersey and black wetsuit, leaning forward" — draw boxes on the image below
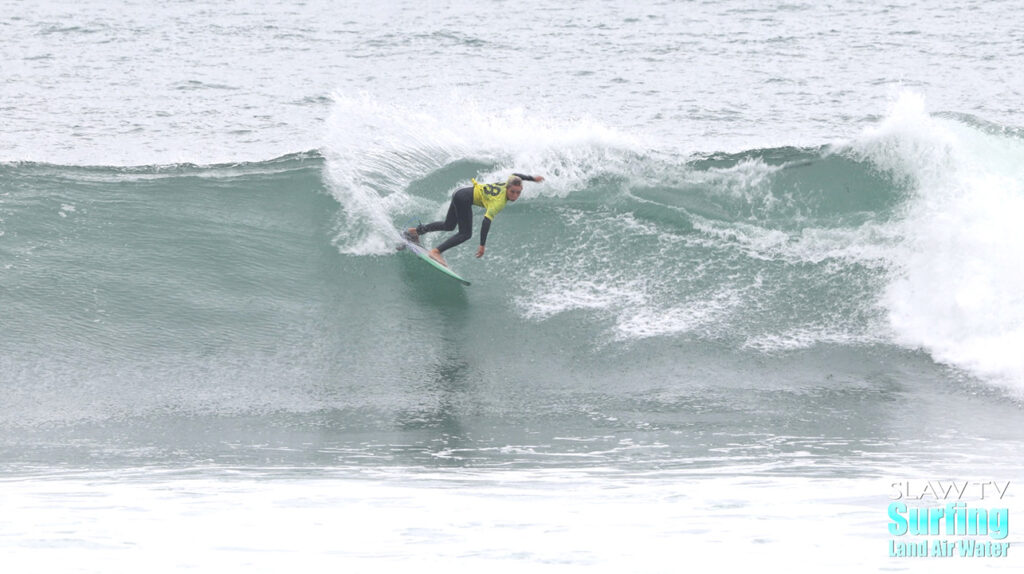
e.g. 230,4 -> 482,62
406,173 -> 544,267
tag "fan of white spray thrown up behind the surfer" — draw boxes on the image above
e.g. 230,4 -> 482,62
323,93 -> 641,255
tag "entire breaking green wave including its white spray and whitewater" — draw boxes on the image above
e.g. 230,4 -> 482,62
0,96 -> 1024,454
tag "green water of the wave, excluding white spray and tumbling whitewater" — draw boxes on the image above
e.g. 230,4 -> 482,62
0,135 -> 1020,476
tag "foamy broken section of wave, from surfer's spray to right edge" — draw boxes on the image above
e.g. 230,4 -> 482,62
319,94 -> 1024,387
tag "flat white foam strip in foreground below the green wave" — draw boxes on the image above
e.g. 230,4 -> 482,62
6,468 -> 1021,573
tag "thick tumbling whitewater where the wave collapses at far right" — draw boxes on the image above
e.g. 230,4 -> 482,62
852,94 -> 1024,390
